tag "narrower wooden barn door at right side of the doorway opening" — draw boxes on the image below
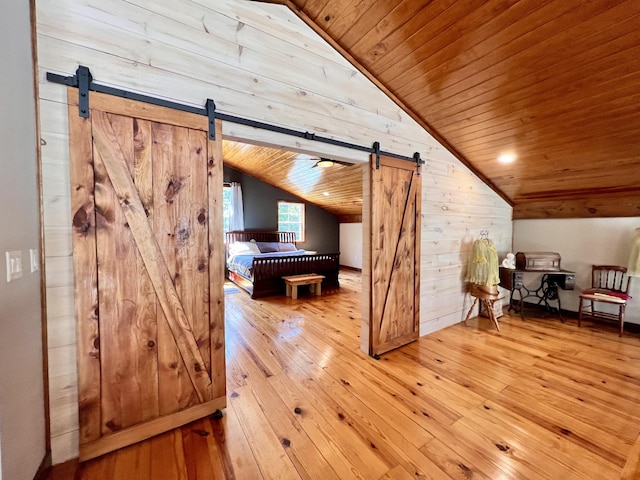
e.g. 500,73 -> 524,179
369,157 -> 422,355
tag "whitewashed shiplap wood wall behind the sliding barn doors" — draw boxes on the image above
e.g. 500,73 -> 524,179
36,0 -> 511,463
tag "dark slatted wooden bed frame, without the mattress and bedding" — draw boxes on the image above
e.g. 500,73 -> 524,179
225,231 -> 340,298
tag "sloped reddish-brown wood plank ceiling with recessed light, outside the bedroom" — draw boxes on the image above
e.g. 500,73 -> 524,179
254,0 -> 640,218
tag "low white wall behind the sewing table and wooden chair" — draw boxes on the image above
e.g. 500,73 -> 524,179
513,217 -> 640,323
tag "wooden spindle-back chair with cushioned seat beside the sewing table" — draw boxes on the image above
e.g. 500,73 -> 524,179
578,265 -> 631,336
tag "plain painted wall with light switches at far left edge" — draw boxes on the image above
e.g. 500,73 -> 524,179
0,2 -> 45,480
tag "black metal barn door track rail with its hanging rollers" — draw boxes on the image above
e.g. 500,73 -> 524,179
47,65 -> 425,175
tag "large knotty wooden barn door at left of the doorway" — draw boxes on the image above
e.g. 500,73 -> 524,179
69,90 -> 226,460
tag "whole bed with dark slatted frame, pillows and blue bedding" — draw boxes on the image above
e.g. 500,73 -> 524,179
226,231 -> 340,298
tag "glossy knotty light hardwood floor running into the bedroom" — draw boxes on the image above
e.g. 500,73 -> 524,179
49,271 -> 640,480
